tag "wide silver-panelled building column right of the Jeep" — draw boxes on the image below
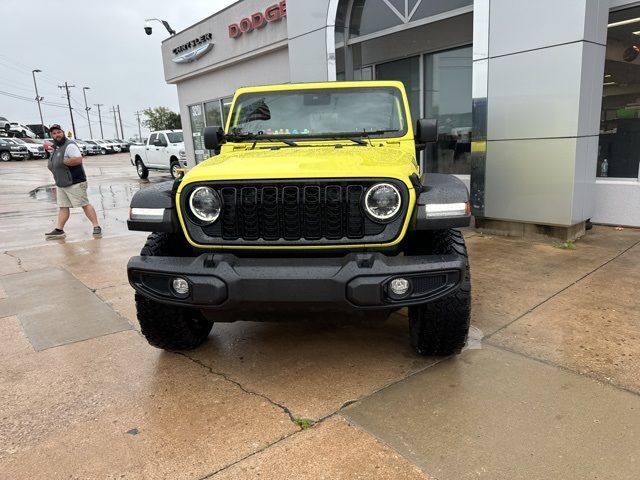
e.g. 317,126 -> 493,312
471,0 -> 609,238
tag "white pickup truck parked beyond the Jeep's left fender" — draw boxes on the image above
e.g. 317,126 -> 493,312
129,130 -> 187,178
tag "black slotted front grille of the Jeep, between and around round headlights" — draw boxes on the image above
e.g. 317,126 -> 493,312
181,179 -> 408,245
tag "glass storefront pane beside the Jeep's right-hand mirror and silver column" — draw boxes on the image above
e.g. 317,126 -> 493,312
424,47 -> 473,174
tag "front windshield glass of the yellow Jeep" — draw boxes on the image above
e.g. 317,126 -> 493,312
229,87 -> 407,137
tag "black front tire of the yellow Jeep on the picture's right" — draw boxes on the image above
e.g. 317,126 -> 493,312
407,229 -> 471,355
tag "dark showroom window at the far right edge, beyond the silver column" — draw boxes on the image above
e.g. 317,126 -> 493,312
596,7 -> 640,179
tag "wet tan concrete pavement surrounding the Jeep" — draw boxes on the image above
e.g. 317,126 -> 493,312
0,155 -> 640,480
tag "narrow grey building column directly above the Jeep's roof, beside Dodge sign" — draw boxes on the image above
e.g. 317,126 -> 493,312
287,0 -> 338,82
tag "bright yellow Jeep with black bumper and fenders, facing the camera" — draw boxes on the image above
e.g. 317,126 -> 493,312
127,81 -> 471,355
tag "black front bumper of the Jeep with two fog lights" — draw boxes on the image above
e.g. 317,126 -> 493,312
127,253 -> 467,310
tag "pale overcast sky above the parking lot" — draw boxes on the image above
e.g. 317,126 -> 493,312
0,0 -> 236,139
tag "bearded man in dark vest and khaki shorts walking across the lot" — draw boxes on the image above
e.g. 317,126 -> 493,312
45,124 -> 102,240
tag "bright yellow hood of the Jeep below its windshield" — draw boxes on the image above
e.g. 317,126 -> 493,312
183,145 -> 418,186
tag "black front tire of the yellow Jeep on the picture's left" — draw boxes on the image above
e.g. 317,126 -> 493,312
135,233 -> 213,350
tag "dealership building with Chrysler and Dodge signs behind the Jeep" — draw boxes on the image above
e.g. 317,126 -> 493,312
162,0 -> 640,238
